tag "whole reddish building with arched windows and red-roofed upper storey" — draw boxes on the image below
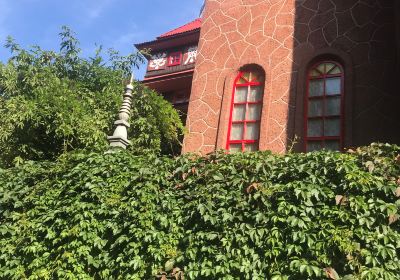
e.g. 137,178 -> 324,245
137,0 -> 400,154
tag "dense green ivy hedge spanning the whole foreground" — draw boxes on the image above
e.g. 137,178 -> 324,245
0,144 -> 400,280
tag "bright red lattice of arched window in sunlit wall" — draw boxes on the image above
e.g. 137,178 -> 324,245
226,72 -> 264,152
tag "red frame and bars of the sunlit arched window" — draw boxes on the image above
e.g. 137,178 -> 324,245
226,71 -> 265,152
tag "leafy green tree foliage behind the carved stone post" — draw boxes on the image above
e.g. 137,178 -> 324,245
0,27 -> 183,166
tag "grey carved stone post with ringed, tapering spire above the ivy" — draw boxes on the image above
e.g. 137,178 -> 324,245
107,74 -> 133,149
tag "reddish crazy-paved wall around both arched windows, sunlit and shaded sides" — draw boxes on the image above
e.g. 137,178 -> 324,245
184,0 -> 400,153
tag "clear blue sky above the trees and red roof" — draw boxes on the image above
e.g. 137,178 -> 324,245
0,0 -> 203,79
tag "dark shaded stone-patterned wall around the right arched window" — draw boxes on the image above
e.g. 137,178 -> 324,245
289,0 -> 400,149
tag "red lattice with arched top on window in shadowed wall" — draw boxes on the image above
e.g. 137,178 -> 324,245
304,61 -> 344,152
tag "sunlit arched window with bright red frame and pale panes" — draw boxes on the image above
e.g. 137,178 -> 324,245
226,71 -> 264,152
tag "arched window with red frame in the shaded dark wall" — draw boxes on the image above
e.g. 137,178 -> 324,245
304,61 -> 344,152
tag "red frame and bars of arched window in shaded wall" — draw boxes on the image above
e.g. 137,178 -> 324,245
304,60 -> 345,152
